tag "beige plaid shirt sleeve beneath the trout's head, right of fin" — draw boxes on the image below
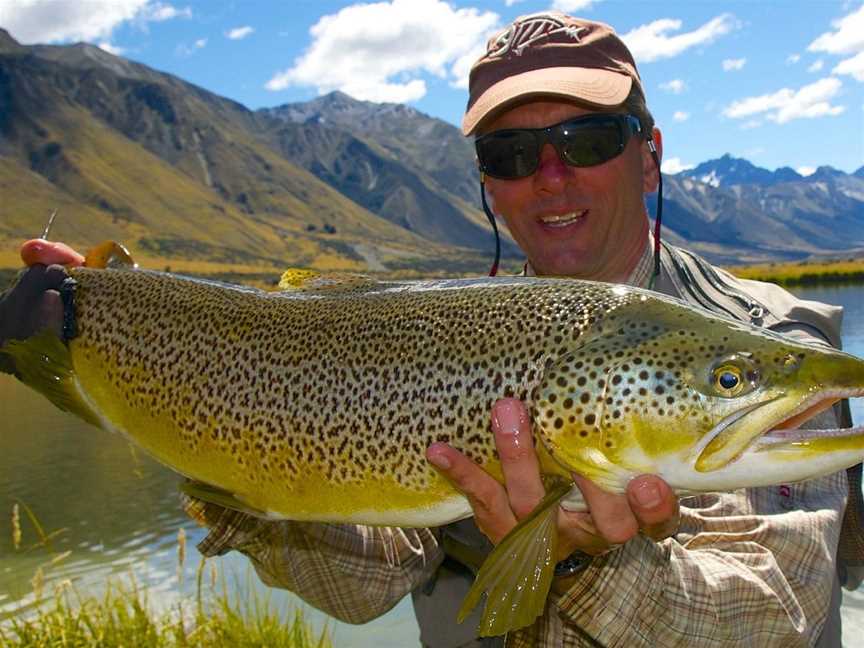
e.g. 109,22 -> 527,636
544,412 -> 847,648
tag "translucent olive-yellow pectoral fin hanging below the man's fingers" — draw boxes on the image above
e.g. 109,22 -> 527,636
458,479 -> 572,637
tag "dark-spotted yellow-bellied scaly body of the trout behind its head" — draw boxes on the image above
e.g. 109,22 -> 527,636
70,268 -> 633,525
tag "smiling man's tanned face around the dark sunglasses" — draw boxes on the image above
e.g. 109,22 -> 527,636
483,101 -> 656,281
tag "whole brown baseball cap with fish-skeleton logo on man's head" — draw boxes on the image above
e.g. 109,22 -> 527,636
462,11 -> 642,135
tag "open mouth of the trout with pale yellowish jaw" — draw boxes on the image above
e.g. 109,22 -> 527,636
693,389 -> 864,472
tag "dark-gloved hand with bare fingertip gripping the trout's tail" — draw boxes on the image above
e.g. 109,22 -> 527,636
0,239 -> 84,373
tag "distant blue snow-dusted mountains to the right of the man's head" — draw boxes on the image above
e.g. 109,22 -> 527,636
649,155 -> 864,263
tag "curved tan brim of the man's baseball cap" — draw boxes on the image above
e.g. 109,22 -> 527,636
462,67 -> 633,135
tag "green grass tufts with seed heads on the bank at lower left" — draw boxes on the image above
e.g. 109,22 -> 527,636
0,502 -> 332,648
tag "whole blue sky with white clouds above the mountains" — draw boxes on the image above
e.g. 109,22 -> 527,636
0,0 -> 864,173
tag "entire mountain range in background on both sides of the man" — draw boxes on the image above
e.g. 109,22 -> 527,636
0,30 -> 864,279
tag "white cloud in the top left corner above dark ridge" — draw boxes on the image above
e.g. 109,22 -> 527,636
0,0 -> 191,44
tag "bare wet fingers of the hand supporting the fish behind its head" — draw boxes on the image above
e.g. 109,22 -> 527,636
426,399 -> 678,560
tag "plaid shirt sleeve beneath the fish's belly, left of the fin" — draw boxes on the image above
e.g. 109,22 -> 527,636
184,498 -> 444,623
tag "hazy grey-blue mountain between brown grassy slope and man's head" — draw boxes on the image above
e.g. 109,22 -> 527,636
259,92 -> 518,255
